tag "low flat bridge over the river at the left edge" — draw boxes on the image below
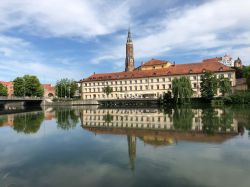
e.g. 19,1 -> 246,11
0,96 -> 44,109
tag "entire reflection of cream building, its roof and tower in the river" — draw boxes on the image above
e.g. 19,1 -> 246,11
81,109 -> 238,170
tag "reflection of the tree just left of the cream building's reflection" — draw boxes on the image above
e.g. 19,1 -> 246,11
56,109 -> 79,130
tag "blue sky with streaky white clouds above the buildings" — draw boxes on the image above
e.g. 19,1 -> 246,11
0,0 -> 250,84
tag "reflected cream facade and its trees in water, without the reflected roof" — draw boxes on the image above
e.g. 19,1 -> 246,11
81,107 -> 239,137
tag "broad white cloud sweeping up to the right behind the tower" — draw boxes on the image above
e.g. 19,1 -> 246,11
93,0 -> 250,66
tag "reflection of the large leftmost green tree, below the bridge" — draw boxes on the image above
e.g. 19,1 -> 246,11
13,112 -> 44,134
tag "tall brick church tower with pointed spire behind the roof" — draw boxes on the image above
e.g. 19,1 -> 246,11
125,29 -> 135,71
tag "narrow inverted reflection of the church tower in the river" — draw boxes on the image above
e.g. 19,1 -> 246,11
127,135 -> 136,170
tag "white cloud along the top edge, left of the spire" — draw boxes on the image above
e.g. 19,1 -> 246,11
0,0 -> 130,37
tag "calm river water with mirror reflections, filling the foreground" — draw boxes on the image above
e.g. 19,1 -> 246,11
0,106 -> 250,187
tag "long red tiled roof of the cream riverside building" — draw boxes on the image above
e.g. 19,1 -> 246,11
83,58 -> 235,82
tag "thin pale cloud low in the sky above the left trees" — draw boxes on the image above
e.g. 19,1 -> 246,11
0,35 -> 83,83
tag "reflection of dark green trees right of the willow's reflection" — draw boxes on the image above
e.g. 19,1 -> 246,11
202,108 -> 233,134
